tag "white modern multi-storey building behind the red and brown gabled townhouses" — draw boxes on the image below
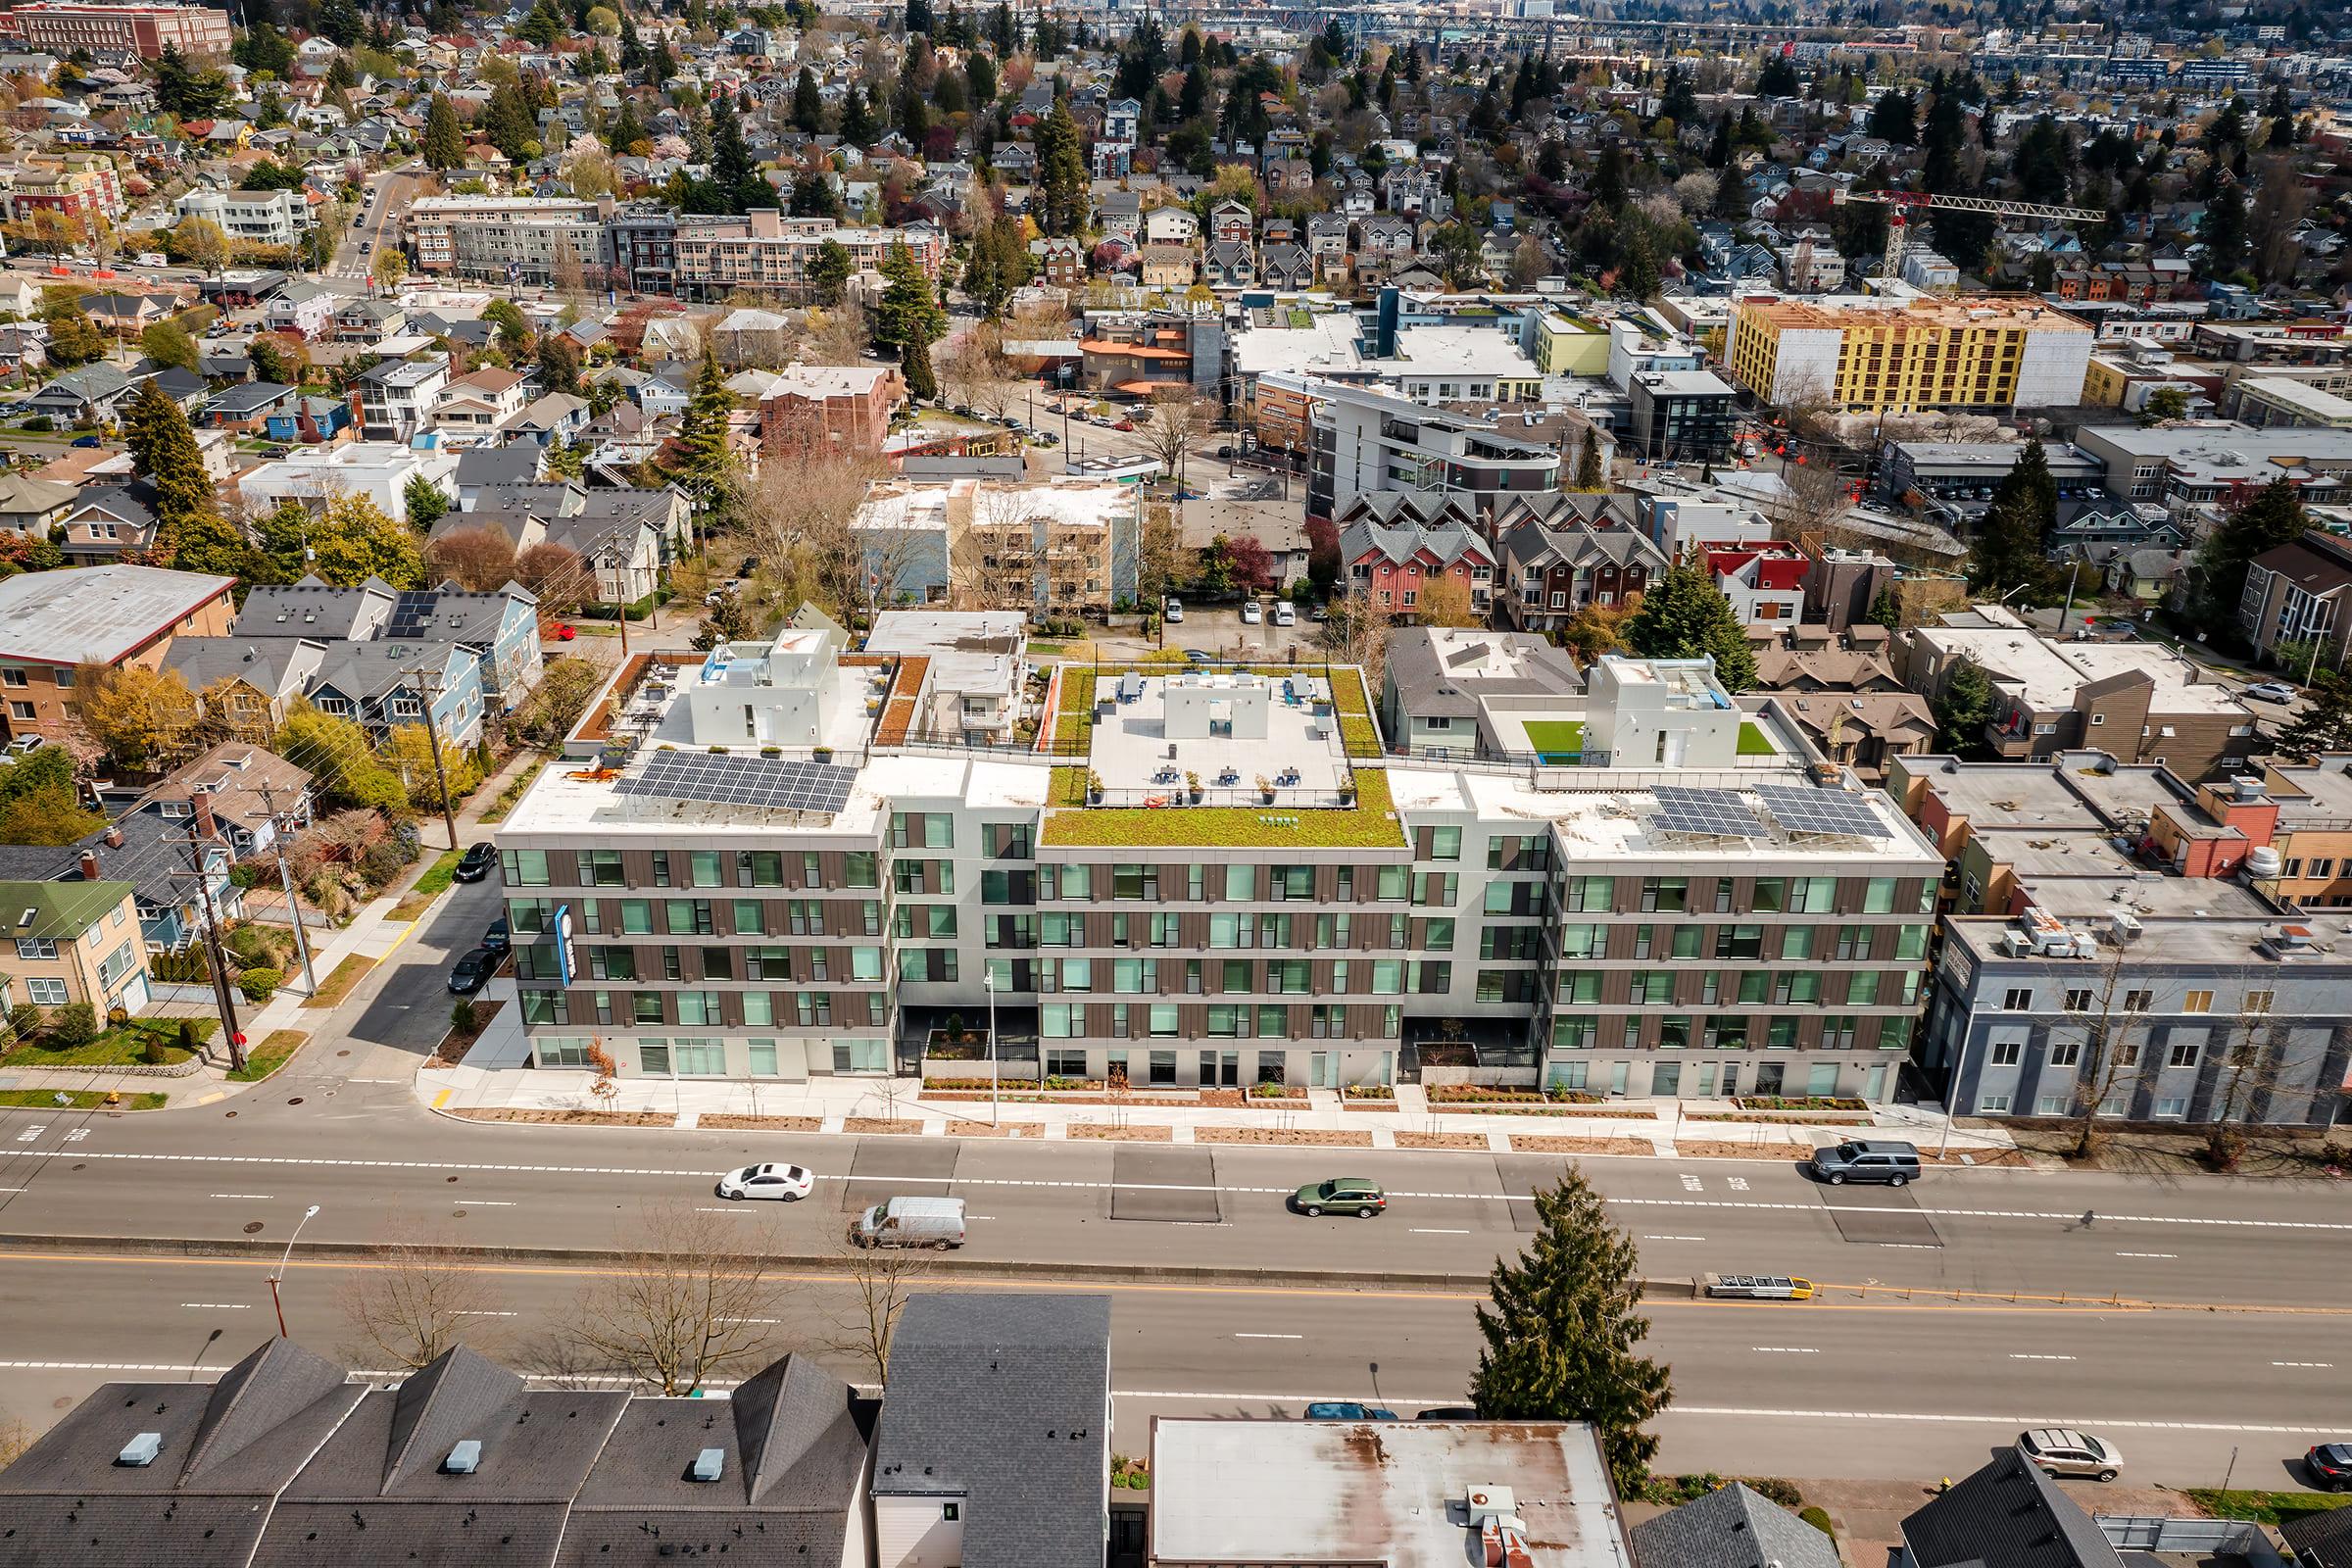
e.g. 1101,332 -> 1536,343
1307,381 -> 1559,517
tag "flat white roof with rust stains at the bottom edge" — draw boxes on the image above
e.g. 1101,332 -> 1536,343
1151,1417 -> 1633,1568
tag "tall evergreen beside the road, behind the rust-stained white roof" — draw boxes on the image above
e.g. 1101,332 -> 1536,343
1470,1166 -> 1675,1497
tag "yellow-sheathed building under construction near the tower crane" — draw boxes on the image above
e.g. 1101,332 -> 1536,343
1724,296 -> 2093,414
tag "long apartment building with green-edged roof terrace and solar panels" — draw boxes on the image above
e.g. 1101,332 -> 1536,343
496,630 -> 1942,1098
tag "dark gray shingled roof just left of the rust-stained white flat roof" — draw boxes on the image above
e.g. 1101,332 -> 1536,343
872,1293 -> 1110,1568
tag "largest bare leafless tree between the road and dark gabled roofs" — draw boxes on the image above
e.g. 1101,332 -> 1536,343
569,1201 -> 786,1394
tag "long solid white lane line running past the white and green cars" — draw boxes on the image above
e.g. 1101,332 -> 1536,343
55,1150 -> 2352,1232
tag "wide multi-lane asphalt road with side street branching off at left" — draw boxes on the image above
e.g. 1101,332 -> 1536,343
0,884 -> 2352,1484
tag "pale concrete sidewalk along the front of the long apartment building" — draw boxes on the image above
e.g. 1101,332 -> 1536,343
416,1029 -> 2018,1163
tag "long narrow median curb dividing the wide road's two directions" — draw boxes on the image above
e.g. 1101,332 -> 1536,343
0,1234 -> 1505,1298
